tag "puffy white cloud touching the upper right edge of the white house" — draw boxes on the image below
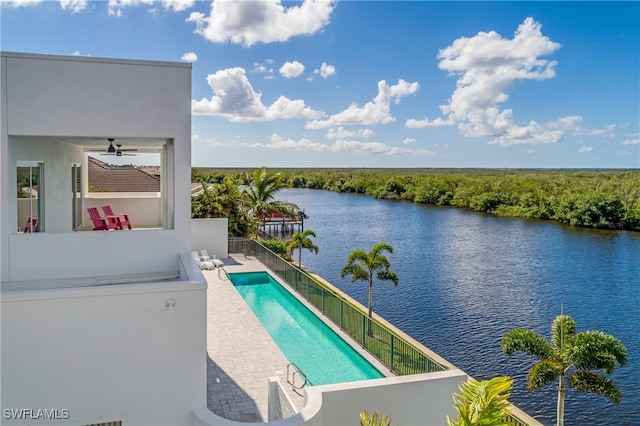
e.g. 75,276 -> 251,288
191,67 -> 322,121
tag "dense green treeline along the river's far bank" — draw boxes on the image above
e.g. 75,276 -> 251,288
192,168 -> 640,231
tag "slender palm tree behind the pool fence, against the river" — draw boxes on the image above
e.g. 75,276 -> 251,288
340,242 -> 398,335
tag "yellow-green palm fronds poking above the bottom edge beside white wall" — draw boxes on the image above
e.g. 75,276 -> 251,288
447,376 -> 513,426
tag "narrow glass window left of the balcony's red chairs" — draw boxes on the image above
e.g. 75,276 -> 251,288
17,161 -> 44,233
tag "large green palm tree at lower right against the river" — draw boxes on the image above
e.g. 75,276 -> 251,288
501,314 -> 627,426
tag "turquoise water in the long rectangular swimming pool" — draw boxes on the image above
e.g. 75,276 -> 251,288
229,272 -> 384,385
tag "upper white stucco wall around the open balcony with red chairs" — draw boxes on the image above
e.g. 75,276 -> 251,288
0,52 -> 191,282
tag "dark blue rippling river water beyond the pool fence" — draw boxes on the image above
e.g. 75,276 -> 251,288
278,189 -> 640,426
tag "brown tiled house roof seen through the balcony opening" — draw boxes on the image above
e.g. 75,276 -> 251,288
89,156 -> 160,192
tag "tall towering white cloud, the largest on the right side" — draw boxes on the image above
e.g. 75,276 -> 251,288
412,18 -> 581,146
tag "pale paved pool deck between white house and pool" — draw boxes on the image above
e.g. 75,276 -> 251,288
202,255 -> 304,423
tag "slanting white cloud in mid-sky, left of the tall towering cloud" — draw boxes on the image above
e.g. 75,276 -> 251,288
305,79 -> 420,129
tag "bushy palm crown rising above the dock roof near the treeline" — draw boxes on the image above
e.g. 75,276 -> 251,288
244,167 -> 298,219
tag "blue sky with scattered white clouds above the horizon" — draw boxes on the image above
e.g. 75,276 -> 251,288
0,0 -> 640,168
